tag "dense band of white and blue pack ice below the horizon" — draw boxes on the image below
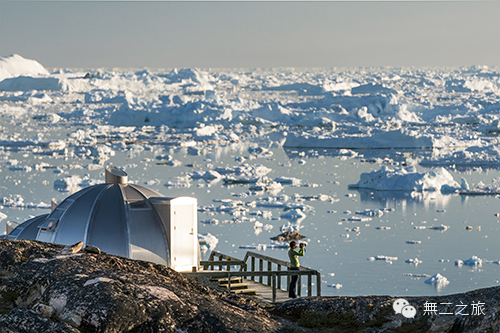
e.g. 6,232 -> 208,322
0,55 -> 500,161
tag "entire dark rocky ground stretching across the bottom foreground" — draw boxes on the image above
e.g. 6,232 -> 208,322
0,240 -> 500,333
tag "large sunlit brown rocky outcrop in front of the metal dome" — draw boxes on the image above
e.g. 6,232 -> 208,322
0,240 -> 281,332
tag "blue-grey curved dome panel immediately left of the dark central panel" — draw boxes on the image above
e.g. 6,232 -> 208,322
49,184 -> 109,245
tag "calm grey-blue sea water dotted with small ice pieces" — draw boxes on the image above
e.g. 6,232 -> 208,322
0,144 -> 500,296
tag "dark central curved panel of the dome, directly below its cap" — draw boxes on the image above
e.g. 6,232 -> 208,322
86,184 -> 129,257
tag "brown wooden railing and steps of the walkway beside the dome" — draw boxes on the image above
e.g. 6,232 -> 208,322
183,251 -> 321,303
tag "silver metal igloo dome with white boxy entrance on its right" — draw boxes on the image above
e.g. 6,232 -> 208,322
5,167 -> 200,271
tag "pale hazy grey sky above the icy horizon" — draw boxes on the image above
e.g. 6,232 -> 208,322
0,0 -> 500,68
